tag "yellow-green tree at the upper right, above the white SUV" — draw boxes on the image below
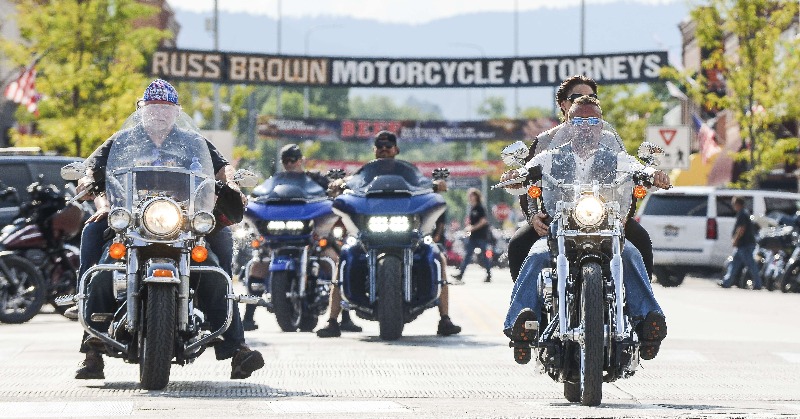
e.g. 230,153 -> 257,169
666,0 -> 800,187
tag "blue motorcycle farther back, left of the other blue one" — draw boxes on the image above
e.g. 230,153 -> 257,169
245,172 -> 339,332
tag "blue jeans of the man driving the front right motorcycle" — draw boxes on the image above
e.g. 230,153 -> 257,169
503,238 -> 663,329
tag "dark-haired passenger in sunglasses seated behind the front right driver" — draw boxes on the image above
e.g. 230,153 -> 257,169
501,75 -> 656,281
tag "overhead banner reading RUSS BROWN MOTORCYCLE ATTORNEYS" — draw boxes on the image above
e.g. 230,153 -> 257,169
150,49 -> 668,88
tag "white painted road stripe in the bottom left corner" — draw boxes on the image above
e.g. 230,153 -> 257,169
0,401 -> 133,418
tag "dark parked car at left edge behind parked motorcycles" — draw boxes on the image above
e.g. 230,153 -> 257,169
0,147 -> 82,227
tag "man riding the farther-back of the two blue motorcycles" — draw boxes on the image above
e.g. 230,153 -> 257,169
242,144 -> 361,332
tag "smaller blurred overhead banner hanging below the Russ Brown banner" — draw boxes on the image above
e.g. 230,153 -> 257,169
257,116 -> 558,143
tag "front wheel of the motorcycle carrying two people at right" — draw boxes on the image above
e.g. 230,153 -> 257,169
564,262 -> 605,406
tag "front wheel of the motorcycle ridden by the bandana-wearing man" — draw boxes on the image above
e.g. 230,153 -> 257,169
139,284 -> 177,390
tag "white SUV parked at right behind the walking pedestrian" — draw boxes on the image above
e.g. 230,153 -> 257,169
637,186 -> 800,286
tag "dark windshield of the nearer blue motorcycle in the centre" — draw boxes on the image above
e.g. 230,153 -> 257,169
347,159 -> 433,195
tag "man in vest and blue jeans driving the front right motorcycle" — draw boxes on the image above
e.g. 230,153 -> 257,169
503,96 -> 669,364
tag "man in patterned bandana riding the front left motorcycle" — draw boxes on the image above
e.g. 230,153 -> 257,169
75,79 -> 264,379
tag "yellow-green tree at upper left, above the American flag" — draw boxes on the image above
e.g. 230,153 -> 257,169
0,0 -> 169,156
